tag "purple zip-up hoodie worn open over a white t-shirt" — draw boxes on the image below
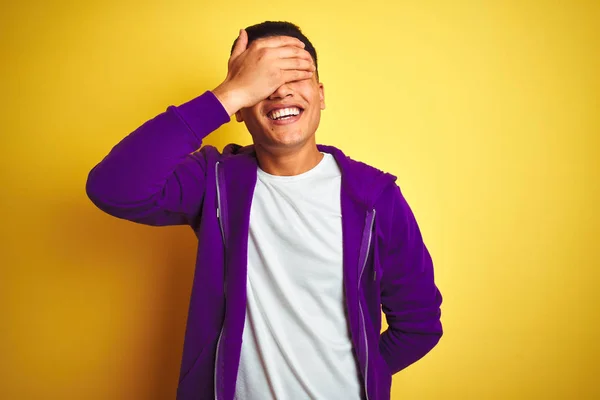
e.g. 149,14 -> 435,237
86,92 -> 442,400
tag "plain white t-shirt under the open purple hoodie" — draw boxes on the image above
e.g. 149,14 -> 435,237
235,153 -> 361,400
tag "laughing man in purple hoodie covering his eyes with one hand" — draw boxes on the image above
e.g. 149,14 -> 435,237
87,22 -> 442,400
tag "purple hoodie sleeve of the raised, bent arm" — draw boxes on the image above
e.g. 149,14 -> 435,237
86,91 -> 230,226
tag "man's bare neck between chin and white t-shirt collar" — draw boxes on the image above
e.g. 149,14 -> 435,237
254,143 -> 323,176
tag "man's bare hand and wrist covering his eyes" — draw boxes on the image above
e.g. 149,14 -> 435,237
213,29 -> 316,116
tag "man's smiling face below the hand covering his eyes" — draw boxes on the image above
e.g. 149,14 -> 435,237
236,75 -> 325,150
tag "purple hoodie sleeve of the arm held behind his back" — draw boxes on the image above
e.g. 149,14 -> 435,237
379,186 -> 442,374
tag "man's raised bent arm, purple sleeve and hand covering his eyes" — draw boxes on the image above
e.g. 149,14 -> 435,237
86,30 -> 315,225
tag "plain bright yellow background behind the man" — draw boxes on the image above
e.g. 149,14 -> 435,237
0,0 -> 600,400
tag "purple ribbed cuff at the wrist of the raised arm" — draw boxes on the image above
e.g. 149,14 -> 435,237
174,91 -> 231,140
